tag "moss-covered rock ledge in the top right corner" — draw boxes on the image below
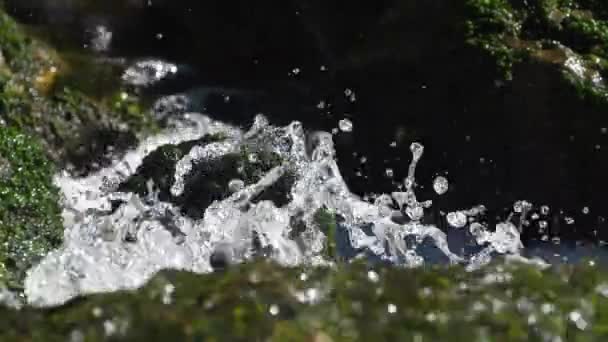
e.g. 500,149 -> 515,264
466,0 -> 608,101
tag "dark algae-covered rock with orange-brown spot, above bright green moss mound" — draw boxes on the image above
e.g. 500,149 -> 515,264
0,10 -> 154,172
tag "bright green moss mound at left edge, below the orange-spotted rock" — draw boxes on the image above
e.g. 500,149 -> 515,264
0,127 -> 63,287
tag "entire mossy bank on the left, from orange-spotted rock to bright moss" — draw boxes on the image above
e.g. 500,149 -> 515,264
0,6 -> 155,289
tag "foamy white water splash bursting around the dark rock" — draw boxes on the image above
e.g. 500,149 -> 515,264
25,114 -> 521,306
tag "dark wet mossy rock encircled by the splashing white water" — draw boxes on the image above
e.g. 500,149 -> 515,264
118,134 -> 293,219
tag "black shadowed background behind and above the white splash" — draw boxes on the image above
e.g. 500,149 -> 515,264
7,0 -> 608,243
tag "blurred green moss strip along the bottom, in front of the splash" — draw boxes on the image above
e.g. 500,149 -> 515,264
0,261 -> 608,341
